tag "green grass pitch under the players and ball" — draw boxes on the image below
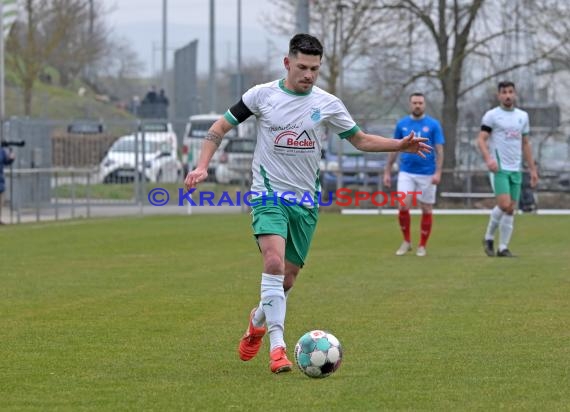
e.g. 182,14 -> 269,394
0,214 -> 570,411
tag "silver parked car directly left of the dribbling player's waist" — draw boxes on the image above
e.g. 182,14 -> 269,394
215,137 -> 256,184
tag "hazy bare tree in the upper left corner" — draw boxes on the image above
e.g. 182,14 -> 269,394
6,0 -> 142,115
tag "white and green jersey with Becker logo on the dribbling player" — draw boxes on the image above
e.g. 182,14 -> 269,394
225,80 -> 360,207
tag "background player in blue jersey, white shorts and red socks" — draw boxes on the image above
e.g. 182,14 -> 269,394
384,93 -> 445,256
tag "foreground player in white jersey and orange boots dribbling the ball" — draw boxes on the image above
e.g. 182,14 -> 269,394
184,34 -> 431,373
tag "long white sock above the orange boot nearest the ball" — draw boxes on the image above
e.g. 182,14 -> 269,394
260,273 -> 287,351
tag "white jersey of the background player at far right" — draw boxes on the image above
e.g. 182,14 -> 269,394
481,106 -> 529,172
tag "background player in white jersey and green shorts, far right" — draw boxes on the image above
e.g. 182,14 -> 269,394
477,81 -> 538,257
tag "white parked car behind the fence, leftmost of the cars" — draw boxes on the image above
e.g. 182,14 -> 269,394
99,133 -> 182,183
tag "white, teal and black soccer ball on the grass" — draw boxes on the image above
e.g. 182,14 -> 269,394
295,330 -> 342,378
